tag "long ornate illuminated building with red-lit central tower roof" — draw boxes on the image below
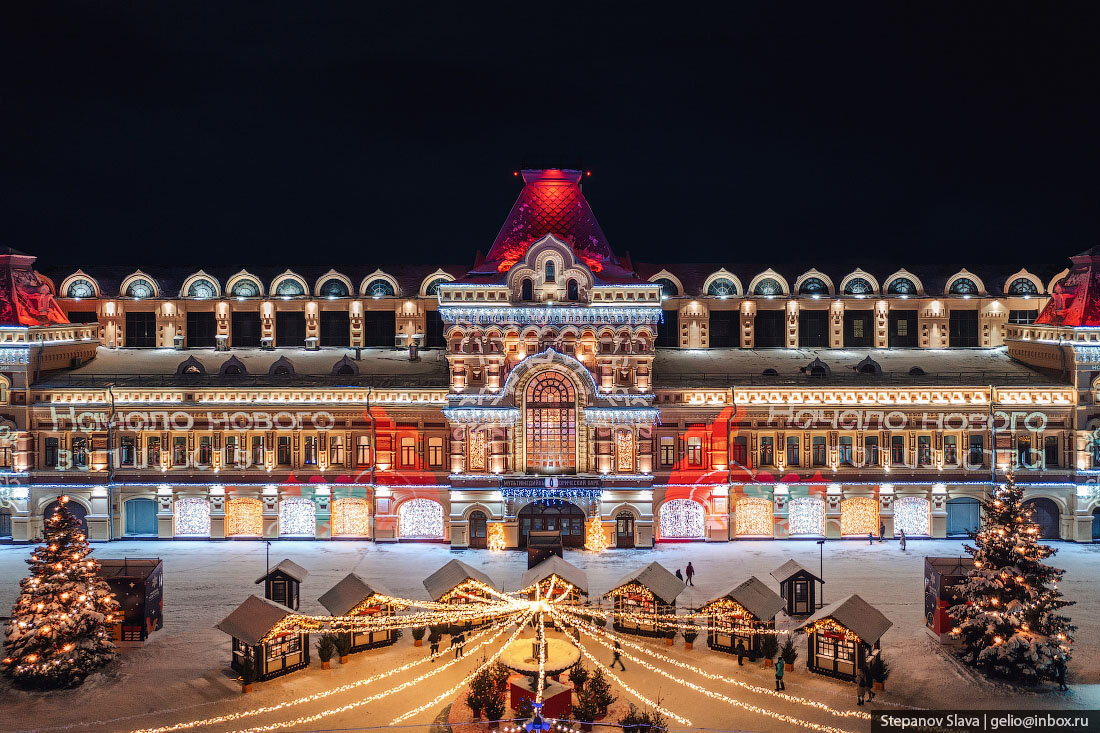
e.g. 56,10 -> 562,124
0,171 -> 1100,547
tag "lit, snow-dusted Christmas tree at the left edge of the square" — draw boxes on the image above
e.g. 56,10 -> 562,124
3,496 -> 118,688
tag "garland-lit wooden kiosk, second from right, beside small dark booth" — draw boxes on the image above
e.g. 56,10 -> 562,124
701,576 -> 783,659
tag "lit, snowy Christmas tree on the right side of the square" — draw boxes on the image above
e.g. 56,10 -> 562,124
948,474 -> 1076,685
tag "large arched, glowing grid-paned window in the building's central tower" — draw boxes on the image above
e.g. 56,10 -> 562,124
525,372 -> 576,473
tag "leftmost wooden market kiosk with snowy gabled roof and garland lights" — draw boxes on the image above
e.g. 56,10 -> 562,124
215,595 -> 309,681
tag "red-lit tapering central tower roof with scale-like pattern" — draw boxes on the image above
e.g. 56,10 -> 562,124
473,168 -> 618,274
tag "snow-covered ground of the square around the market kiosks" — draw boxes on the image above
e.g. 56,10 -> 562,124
0,540 -> 1100,731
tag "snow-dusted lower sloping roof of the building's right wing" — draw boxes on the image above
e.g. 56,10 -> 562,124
653,347 -> 1059,389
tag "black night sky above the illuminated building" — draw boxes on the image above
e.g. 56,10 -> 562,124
0,1 -> 1100,266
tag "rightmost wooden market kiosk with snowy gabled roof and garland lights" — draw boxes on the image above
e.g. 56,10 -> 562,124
799,595 -> 893,681
